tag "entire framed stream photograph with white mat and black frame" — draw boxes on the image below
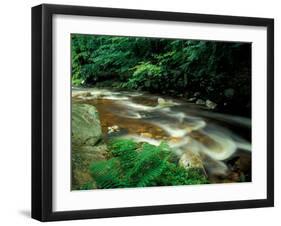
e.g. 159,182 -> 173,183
32,4 -> 274,221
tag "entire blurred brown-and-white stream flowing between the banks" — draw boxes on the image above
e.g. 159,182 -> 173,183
72,88 -> 251,183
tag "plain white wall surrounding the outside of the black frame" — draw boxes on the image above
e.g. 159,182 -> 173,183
0,0 -> 276,226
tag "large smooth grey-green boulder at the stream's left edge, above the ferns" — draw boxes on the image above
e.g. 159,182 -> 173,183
71,103 -> 102,146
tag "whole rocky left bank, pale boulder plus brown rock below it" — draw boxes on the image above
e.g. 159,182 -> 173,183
71,103 -> 108,190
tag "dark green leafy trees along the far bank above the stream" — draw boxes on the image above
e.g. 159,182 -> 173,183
72,34 -> 251,116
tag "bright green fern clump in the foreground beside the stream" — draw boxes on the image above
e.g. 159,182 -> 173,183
90,140 -> 208,188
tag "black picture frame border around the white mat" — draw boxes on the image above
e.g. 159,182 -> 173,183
32,4 -> 274,221
